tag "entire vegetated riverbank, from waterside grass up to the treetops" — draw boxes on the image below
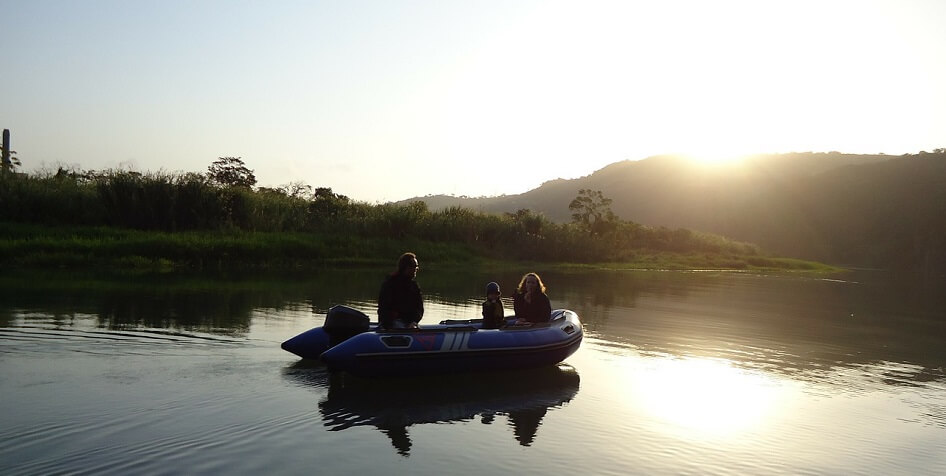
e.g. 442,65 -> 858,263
0,158 -> 823,270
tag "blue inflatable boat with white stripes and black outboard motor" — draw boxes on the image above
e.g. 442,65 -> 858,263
282,306 -> 583,377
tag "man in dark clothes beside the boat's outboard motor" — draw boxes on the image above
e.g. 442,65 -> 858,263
378,252 -> 424,329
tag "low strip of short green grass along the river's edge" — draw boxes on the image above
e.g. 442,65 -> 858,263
0,223 -> 839,272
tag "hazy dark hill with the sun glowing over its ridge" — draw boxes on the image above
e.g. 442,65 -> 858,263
398,149 -> 946,270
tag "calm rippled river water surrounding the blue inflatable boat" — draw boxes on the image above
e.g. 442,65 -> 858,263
0,262 -> 946,475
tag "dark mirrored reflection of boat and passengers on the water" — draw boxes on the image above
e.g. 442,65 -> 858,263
287,364 -> 580,456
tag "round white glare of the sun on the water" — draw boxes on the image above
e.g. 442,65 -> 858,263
629,357 -> 785,438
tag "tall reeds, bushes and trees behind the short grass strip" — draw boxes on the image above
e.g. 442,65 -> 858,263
0,157 -> 766,264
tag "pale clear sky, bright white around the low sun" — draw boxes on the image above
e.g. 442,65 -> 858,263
0,0 -> 946,203
